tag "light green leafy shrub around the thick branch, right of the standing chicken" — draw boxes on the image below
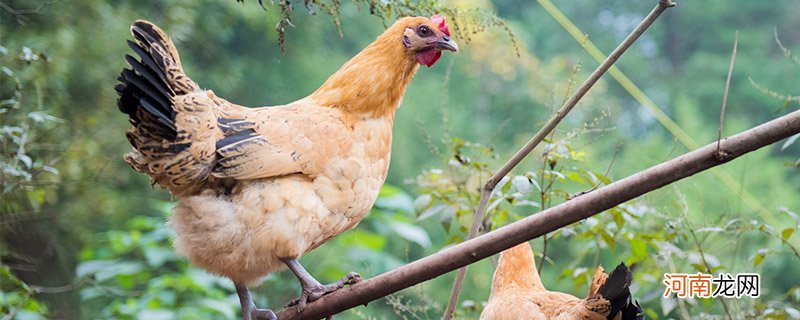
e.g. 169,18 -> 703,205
409,136 -> 800,319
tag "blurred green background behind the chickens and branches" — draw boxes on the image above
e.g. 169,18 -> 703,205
0,0 -> 800,319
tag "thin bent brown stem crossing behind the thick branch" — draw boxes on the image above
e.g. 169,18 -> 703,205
443,0 -> 674,320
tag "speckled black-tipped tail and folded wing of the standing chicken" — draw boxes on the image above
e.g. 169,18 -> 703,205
116,20 -> 340,196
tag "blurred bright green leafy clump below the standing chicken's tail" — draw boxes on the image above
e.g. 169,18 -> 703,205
76,208 -> 239,319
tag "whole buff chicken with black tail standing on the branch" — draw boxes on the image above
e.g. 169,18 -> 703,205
116,15 -> 459,319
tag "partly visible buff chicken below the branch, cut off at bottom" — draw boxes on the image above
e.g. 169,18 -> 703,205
481,242 -> 644,320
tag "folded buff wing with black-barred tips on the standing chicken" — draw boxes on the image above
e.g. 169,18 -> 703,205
212,103 -> 352,180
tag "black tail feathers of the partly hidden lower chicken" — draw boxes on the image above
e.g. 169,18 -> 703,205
599,263 -> 644,320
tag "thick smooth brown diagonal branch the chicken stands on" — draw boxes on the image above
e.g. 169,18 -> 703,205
278,111 -> 800,320
